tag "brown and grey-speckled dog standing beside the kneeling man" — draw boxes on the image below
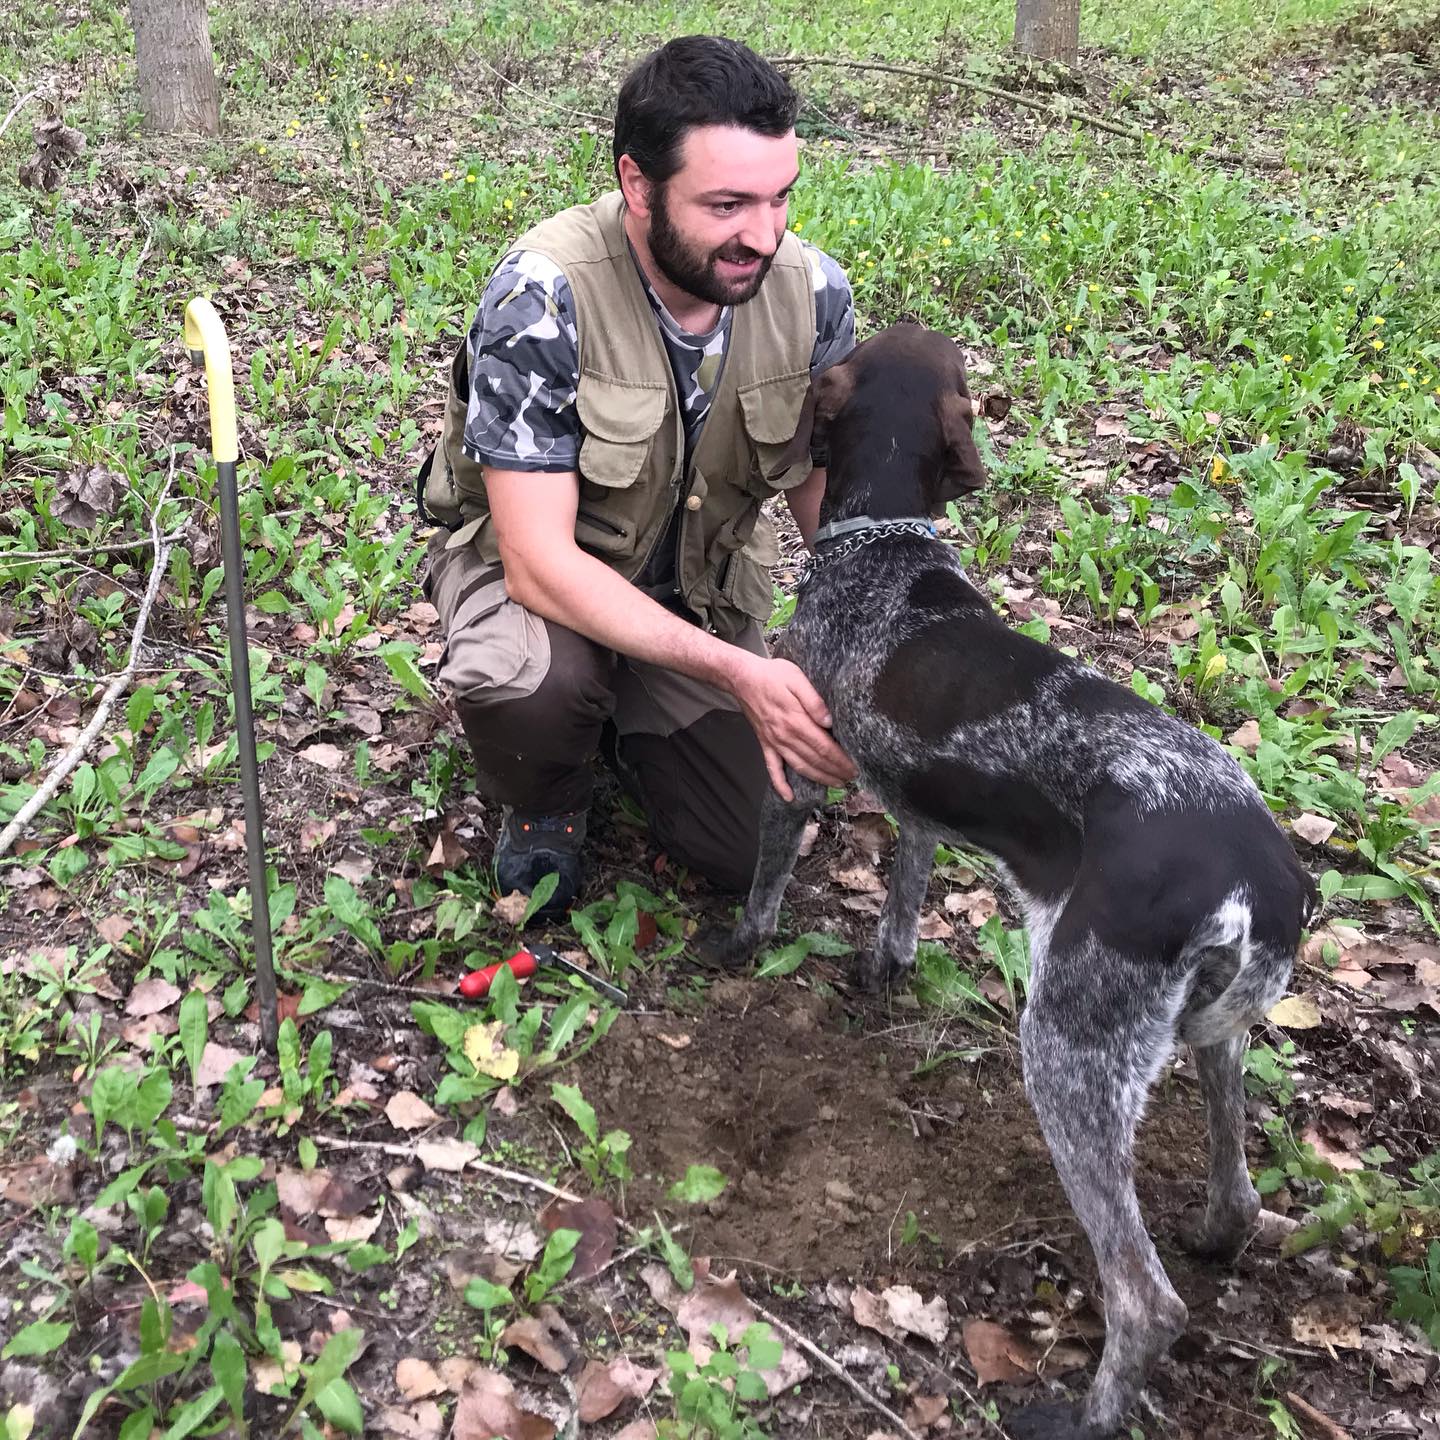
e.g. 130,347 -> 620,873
703,324 -> 1315,1440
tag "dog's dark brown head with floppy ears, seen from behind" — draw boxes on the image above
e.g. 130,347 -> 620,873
812,323 -> 985,516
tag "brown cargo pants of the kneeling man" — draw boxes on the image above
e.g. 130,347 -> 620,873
425,531 -> 769,891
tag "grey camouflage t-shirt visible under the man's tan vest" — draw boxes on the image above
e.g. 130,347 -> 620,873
464,245 -> 855,474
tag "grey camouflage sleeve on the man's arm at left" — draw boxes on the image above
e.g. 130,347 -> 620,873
464,251 -> 580,472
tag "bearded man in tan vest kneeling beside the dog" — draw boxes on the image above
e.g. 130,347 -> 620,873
422,36 -> 854,913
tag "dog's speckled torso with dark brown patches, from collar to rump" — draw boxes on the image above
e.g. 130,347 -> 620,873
783,537 -> 1312,1002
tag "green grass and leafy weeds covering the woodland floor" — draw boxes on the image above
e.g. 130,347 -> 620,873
0,0 -> 1440,1436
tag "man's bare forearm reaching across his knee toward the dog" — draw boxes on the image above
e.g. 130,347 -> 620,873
505,549 -> 753,693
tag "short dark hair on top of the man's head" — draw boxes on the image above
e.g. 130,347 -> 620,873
615,35 -> 801,181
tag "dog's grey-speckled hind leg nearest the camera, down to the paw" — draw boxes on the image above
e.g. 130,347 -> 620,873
1007,940 -> 1187,1440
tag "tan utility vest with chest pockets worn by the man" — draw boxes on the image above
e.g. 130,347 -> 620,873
423,190 -> 815,639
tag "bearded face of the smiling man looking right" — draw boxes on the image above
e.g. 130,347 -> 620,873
648,125 -> 799,305
